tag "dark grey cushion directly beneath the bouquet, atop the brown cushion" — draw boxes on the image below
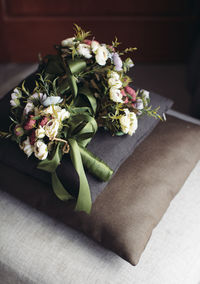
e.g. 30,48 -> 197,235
0,74 -> 172,201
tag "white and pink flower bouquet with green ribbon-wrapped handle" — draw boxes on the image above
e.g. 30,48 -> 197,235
0,25 -> 162,213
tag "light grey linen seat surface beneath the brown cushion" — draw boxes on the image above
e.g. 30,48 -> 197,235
0,159 -> 200,284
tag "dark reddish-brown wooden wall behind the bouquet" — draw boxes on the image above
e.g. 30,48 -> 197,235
0,0 -> 195,63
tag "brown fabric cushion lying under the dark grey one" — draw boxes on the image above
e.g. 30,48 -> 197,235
0,114 -> 200,265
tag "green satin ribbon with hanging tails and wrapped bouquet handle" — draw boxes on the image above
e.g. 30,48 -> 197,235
38,57 -> 113,214
